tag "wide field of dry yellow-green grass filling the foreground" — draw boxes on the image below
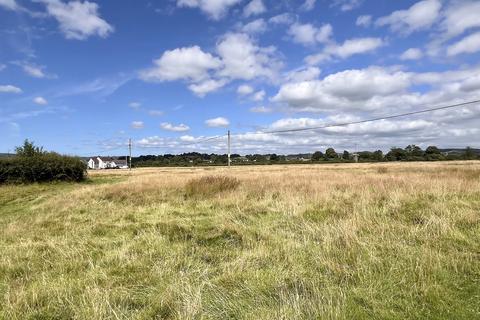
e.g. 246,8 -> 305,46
0,162 -> 480,319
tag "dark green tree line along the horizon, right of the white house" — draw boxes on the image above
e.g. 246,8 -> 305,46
132,145 -> 480,167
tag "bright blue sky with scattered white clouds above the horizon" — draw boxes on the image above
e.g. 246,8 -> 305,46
0,0 -> 480,156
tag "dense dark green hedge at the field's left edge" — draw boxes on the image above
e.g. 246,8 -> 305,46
0,152 -> 87,183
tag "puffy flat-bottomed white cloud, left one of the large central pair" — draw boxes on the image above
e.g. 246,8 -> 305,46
140,46 -> 222,82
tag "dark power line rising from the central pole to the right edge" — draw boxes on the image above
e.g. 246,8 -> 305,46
232,100 -> 480,136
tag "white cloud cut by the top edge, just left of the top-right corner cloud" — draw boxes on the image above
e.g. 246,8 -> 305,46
375,0 -> 442,35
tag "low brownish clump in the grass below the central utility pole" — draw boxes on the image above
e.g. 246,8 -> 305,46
185,176 -> 240,196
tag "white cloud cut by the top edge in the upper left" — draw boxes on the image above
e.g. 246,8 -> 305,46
37,0 -> 114,40
